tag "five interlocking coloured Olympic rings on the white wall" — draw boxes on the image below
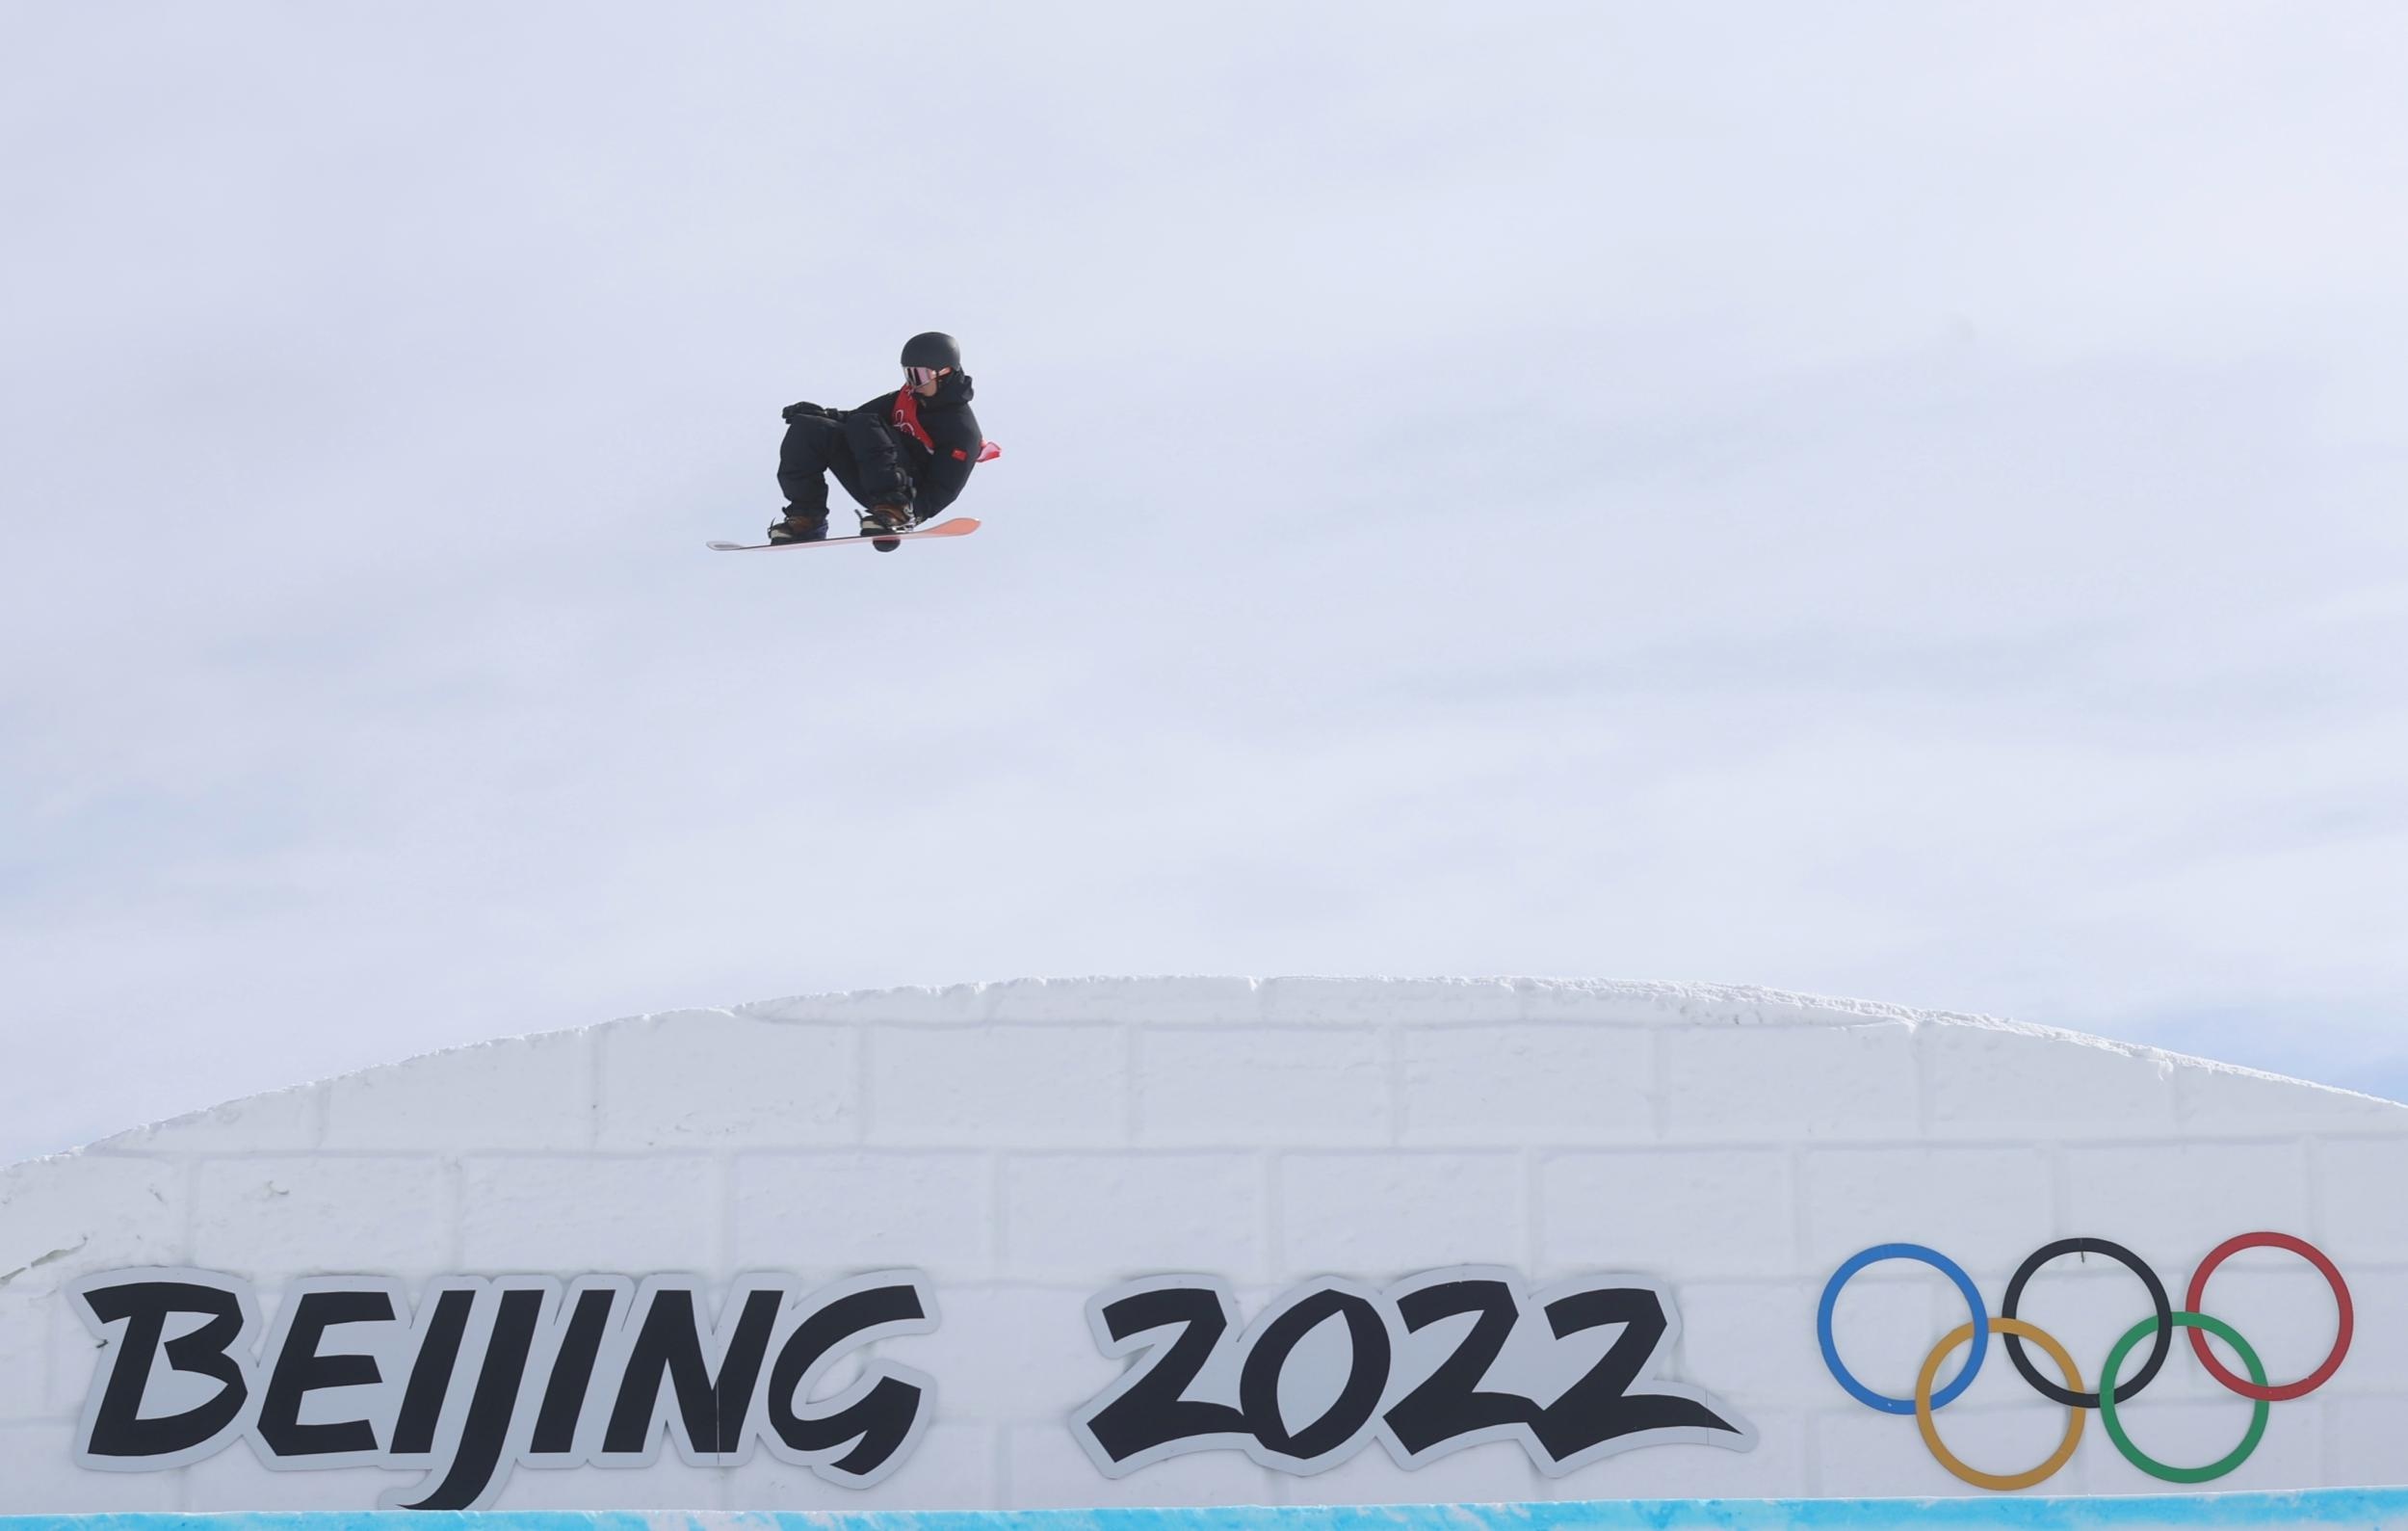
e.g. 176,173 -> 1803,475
1816,1232 -> 2358,1491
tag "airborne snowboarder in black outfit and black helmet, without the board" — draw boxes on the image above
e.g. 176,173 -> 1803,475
769,330 -> 985,554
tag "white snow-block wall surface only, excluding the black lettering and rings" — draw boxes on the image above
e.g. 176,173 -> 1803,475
0,980 -> 2408,1512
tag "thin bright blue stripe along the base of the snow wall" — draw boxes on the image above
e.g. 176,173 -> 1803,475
0,1488 -> 2408,1531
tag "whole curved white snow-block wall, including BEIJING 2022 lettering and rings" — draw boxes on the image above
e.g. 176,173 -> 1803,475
0,977 -> 2408,1531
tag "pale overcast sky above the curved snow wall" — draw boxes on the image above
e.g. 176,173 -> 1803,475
0,0 -> 2408,1160
